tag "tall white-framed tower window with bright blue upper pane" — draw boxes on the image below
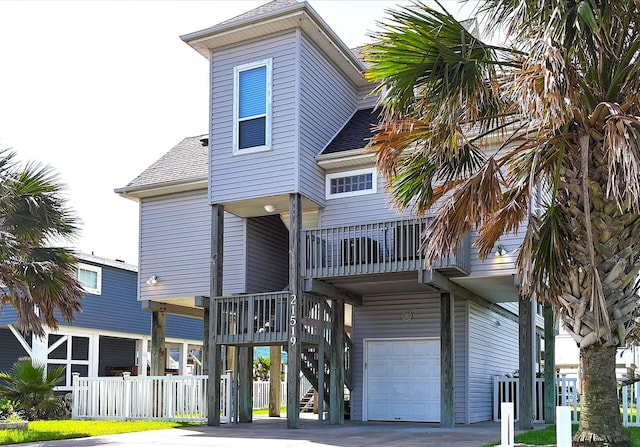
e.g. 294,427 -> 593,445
233,59 -> 271,154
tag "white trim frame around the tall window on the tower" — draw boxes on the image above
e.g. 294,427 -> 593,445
233,58 -> 272,155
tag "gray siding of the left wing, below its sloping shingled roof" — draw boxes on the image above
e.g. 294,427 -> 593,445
138,189 -> 244,300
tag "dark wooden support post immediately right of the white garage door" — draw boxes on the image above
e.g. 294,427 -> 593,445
440,292 -> 456,428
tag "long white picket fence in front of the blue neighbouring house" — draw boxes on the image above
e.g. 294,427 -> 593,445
71,374 -> 231,423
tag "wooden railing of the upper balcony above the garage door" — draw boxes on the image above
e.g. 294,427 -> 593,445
301,218 -> 471,278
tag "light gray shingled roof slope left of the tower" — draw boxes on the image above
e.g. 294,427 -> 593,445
117,135 -> 208,192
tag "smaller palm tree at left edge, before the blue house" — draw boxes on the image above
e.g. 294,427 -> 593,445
0,150 -> 83,336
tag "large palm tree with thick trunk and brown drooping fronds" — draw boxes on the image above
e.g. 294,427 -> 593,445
366,0 -> 640,446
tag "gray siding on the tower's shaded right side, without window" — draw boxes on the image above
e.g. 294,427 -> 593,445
300,34 -> 358,204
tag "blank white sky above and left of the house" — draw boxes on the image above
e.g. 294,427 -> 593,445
0,0 -> 476,264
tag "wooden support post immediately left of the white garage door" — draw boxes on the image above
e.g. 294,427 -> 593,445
330,300 -> 344,425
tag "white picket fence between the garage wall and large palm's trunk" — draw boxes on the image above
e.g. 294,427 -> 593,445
493,376 -> 578,423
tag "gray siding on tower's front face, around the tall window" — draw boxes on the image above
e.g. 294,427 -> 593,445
209,32 -> 298,203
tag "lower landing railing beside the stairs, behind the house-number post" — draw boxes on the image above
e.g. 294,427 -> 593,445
214,292 -> 331,345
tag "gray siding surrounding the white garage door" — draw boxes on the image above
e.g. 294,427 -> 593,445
351,292 -> 467,423
